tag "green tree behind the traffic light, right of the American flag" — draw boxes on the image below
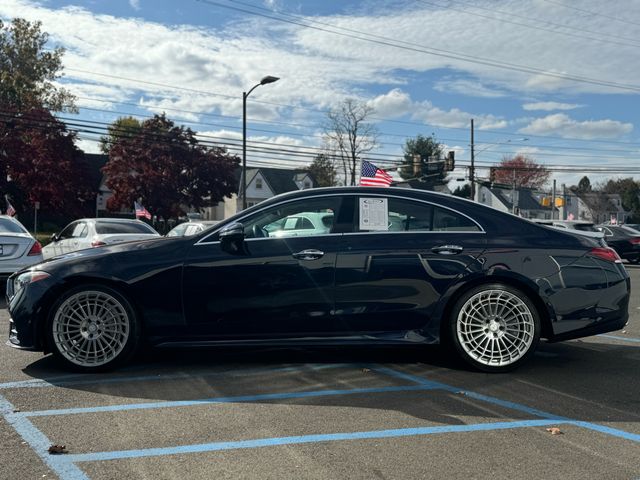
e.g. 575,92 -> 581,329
398,134 -> 447,189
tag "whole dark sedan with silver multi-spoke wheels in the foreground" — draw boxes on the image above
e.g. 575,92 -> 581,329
7,187 -> 630,372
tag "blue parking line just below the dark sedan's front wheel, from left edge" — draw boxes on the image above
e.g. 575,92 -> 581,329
0,363 -> 344,390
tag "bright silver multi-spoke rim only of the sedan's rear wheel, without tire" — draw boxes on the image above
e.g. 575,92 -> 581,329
456,290 -> 535,366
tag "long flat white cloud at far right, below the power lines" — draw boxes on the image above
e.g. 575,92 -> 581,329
519,113 -> 633,140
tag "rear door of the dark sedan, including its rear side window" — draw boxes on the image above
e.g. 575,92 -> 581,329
335,198 -> 486,333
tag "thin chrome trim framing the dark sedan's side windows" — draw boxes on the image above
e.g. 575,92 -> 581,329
194,192 -> 487,246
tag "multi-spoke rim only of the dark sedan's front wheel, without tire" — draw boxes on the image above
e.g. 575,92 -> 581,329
53,290 -> 131,367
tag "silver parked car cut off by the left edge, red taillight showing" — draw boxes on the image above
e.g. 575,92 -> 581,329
0,215 -> 42,281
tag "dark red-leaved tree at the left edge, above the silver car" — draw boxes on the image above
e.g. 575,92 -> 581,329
0,109 -> 95,215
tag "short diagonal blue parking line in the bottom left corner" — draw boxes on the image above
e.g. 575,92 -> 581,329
0,395 -> 89,480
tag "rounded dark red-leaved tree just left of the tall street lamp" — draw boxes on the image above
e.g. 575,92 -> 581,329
102,114 -> 239,218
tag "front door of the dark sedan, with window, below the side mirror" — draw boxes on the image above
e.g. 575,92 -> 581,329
183,197 -> 342,338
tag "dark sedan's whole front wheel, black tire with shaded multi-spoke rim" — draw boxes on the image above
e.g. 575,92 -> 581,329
46,284 -> 141,373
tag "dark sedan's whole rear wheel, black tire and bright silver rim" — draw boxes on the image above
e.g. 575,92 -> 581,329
450,283 -> 540,372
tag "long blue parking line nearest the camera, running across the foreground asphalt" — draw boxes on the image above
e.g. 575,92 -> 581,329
62,420 -> 556,462
